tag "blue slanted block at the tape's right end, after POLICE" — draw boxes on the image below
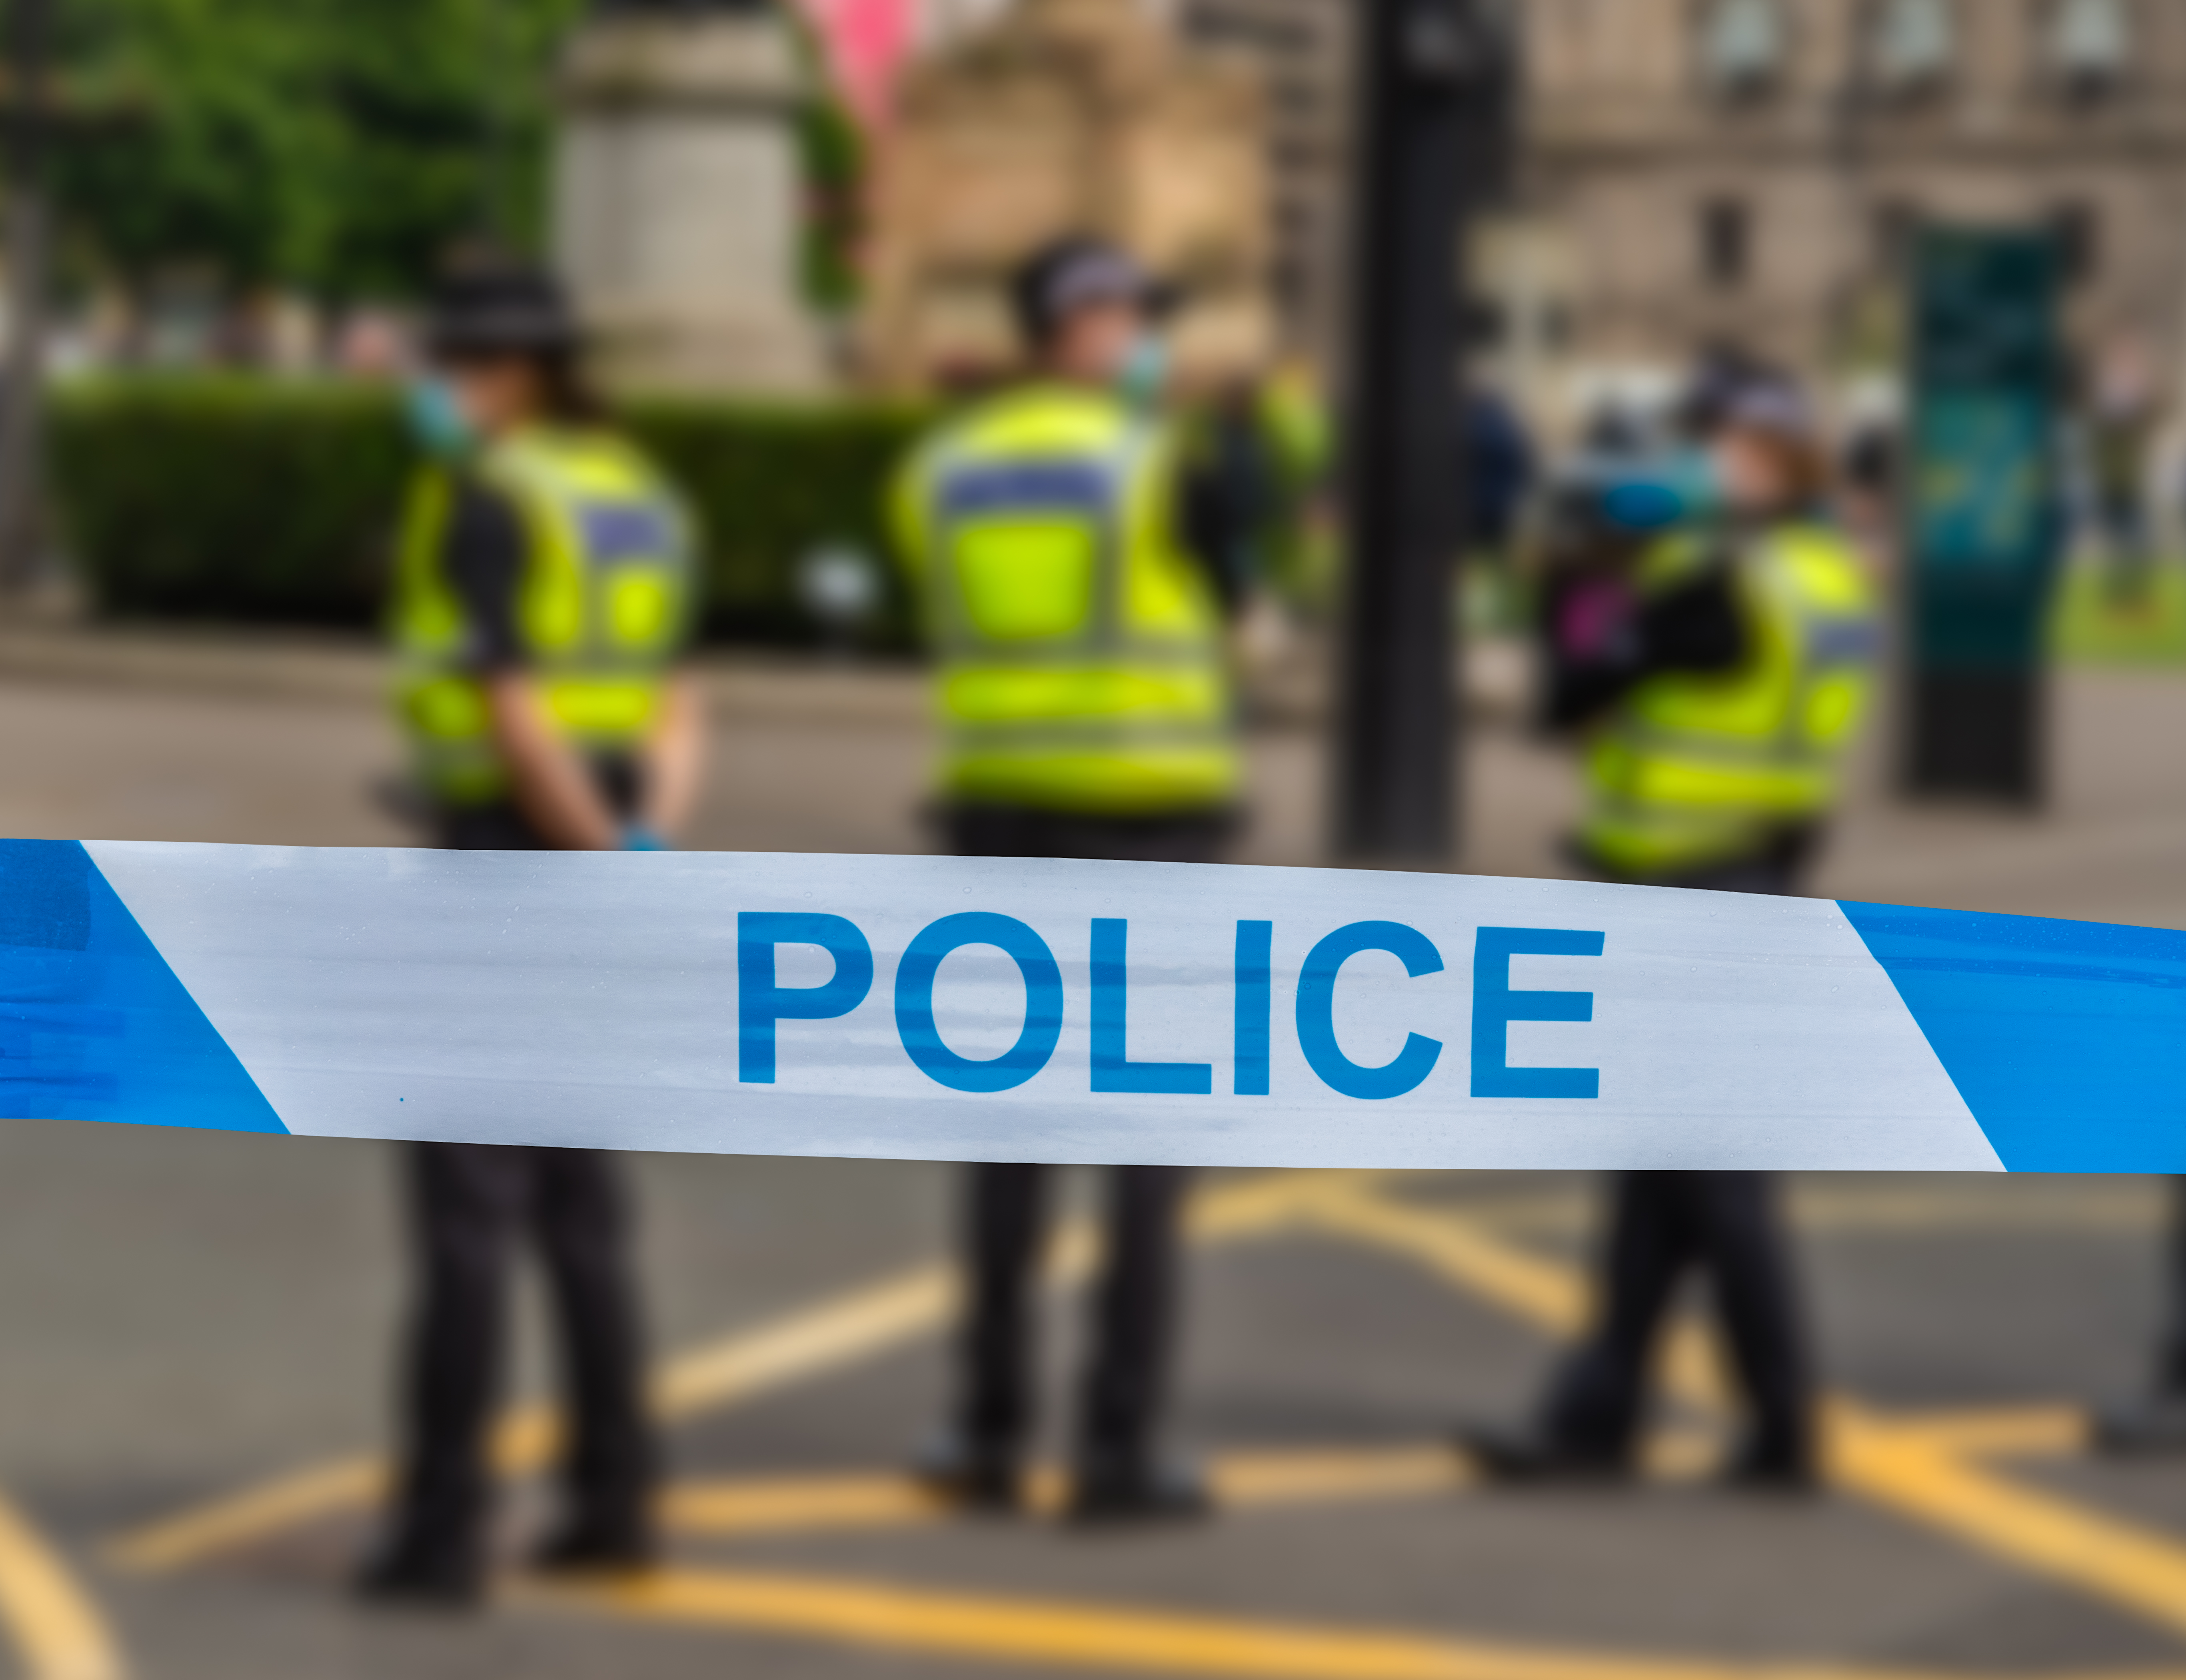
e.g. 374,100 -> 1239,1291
1840,905 -> 2186,1173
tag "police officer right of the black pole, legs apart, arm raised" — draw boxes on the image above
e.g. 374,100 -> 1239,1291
1460,380 -> 1876,1488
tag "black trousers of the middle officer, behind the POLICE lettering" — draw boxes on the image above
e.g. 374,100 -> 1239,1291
947,806 -> 1231,1464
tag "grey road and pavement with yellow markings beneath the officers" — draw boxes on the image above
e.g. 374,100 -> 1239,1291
0,651 -> 2186,1680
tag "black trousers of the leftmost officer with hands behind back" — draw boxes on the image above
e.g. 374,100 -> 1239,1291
380,806 -> 658,1562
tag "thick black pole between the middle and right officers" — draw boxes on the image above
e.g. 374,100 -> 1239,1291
1336,0 -> 1511,867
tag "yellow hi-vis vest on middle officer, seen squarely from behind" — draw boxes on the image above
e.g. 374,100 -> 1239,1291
894,387 -> 1242,815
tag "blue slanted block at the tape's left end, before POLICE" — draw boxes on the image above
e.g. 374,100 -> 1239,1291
0,841 -> 289,1132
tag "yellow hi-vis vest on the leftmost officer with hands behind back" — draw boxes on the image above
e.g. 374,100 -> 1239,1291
389,426 -> 691,806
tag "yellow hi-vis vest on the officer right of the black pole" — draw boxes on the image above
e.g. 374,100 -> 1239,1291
1578,524 -> 1878,881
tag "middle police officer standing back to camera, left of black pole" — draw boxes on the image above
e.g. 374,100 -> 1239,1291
894,238 -> 1242,1520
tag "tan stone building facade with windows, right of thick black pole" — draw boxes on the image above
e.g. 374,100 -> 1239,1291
1524,0 -> 2186,406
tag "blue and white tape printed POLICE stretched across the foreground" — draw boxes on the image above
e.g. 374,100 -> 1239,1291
0,841 -> 2186,1171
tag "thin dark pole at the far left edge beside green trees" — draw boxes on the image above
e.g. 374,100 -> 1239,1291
0,0 -> 52,590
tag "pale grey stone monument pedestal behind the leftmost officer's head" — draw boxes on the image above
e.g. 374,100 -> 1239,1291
553,0 -> 829,391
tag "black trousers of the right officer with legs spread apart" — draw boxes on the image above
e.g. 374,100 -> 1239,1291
1543,848 -> 1812,1468
